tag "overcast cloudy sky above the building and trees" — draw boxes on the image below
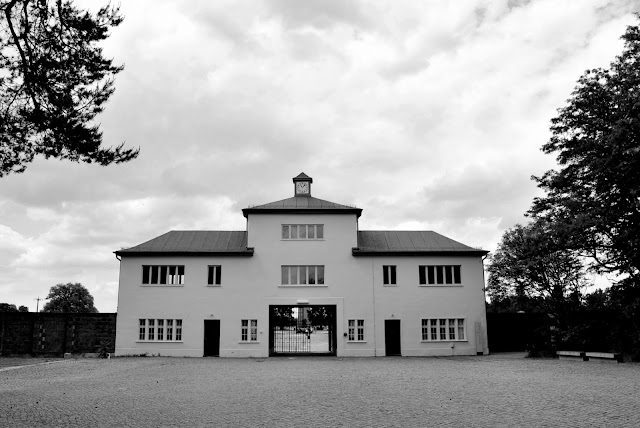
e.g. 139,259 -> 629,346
0,0 -> 640,312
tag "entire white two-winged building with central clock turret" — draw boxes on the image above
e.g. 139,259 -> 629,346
115,173 -> 488,357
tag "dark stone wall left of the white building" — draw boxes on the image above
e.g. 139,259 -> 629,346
0,312 -> 116,356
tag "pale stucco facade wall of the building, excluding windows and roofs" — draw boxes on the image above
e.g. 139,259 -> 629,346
116,214 -> 488,357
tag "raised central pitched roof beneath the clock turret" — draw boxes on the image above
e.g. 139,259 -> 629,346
242,196 -> 362,217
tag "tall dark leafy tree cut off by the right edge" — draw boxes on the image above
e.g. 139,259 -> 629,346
529,14 -> 640,280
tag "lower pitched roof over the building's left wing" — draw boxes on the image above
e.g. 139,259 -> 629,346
115,230 -> 253,256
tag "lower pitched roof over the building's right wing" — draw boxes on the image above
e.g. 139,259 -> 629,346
352,230 -> 488,256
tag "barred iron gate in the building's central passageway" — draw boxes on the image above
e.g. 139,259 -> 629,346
269,305 -> 336,356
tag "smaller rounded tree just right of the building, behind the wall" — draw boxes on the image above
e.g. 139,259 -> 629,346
487,220 -> 585,327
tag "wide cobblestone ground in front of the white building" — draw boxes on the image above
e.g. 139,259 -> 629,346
0,354 -> 640,427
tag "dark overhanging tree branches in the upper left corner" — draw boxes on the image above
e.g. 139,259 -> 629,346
0,0 -> 139,177
